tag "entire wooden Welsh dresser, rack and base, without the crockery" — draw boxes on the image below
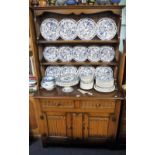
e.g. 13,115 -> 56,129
30,5 -> 125,146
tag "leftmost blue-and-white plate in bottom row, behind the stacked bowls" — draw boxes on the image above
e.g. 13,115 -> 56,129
45,66 -> 61,79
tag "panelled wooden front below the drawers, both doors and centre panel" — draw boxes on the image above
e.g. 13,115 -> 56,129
40,112 -> 116,139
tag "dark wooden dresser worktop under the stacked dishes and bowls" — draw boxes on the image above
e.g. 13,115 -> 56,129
34,86 -> 123,100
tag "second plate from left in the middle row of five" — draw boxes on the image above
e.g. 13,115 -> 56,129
59,46 -> 73,62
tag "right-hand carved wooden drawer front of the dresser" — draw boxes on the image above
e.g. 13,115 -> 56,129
80,100 -> 115,109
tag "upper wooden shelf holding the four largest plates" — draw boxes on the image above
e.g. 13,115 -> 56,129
37,39 -> 119,44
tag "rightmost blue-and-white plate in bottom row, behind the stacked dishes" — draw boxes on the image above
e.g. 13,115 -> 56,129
95,66 -> 113,81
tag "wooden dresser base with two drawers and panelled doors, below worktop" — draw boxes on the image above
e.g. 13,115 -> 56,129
35,98 -> 121,147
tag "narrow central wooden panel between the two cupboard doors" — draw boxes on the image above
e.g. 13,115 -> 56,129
72,113 -> 83,139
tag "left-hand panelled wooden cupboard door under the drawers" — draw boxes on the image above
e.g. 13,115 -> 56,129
46,112 -> 70,137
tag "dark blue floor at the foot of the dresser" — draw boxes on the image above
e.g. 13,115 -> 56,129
29,139 -> 126,155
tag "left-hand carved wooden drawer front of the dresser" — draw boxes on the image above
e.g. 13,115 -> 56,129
40,99 -> 74,108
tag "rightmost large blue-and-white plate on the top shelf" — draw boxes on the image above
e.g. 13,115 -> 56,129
97,18 -> 117,40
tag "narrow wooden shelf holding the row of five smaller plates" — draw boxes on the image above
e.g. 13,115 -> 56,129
41,59 -> 118,66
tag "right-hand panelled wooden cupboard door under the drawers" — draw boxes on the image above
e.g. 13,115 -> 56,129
84,113 -> 113,138
